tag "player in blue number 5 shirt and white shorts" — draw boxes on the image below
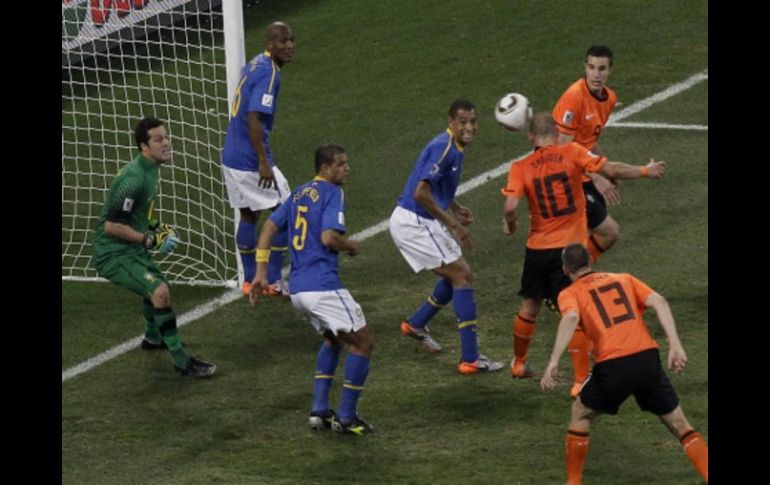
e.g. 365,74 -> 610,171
250,144 -> 374,435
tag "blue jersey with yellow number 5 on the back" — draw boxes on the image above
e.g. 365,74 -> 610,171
270,177 -> 345,294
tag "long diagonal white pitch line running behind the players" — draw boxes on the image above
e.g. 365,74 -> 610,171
61,70 -> 708,382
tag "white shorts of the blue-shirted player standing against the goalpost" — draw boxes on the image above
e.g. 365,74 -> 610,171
222,165 -> 291,211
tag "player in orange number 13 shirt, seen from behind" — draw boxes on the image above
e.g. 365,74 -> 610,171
540,243 -> 708,484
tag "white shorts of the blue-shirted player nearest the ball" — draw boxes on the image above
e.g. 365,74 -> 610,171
389,206 -> 463,273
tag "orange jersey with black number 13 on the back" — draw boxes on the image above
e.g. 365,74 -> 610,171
559,273 -> 658,362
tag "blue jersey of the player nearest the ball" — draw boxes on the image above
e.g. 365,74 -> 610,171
398,129 -> 465,219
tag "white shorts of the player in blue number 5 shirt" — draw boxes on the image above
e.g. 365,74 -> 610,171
291,288 -> 366,335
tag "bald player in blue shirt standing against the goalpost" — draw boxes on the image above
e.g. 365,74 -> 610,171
222,22 -> 294,296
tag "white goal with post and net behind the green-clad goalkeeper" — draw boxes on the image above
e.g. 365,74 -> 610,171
62,0 -> 245,286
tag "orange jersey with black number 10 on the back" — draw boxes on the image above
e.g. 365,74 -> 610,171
501,143 -> 607,249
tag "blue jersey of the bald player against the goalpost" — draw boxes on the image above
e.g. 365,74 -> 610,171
222,51 -> 281,172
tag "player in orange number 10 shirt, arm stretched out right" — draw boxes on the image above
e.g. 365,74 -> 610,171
502,113 -> 666,378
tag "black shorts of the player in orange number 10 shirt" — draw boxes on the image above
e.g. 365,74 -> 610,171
519,248 -> 571,303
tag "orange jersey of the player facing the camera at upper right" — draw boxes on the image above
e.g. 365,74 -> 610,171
551,78 -> 618,150
